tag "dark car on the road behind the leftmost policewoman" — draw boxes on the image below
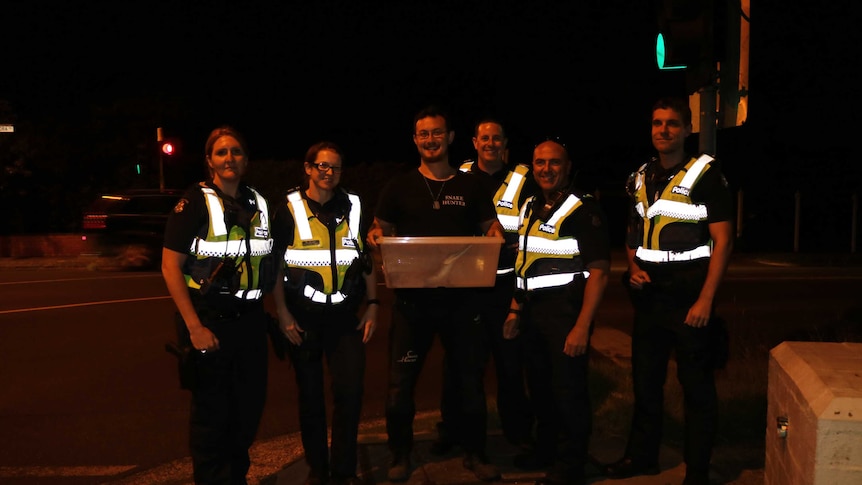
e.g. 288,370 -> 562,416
82,189 -> 183,268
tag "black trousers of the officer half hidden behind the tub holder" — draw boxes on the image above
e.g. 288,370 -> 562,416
440,272 -> 534,445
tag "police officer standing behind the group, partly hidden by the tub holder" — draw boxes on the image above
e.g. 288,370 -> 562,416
430,117 -> 536,454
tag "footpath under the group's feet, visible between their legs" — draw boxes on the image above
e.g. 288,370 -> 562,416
104,327 -> 748,485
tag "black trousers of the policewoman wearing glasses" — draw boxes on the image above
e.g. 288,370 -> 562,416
290,308 -> 365,478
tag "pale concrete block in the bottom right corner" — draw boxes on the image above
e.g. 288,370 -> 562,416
764,342 -> 862,485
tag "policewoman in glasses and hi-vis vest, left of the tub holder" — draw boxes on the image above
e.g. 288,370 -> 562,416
273,141 -> 380,485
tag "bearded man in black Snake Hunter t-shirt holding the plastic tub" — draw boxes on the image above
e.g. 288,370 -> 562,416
368,107 -> 503,482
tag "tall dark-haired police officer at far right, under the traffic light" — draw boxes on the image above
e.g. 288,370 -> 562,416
605,98 -> 733,485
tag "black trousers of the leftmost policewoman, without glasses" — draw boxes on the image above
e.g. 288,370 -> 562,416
189,305 -> 269,485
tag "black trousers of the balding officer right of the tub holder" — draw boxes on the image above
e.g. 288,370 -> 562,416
521,290 -> 593,479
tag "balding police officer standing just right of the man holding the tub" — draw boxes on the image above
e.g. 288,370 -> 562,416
503,140 -> 610,485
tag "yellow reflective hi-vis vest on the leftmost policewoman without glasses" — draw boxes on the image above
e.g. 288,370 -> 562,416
185,185 -> 272,300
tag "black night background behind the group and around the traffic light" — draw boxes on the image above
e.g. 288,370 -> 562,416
0,0 -> 862,250
